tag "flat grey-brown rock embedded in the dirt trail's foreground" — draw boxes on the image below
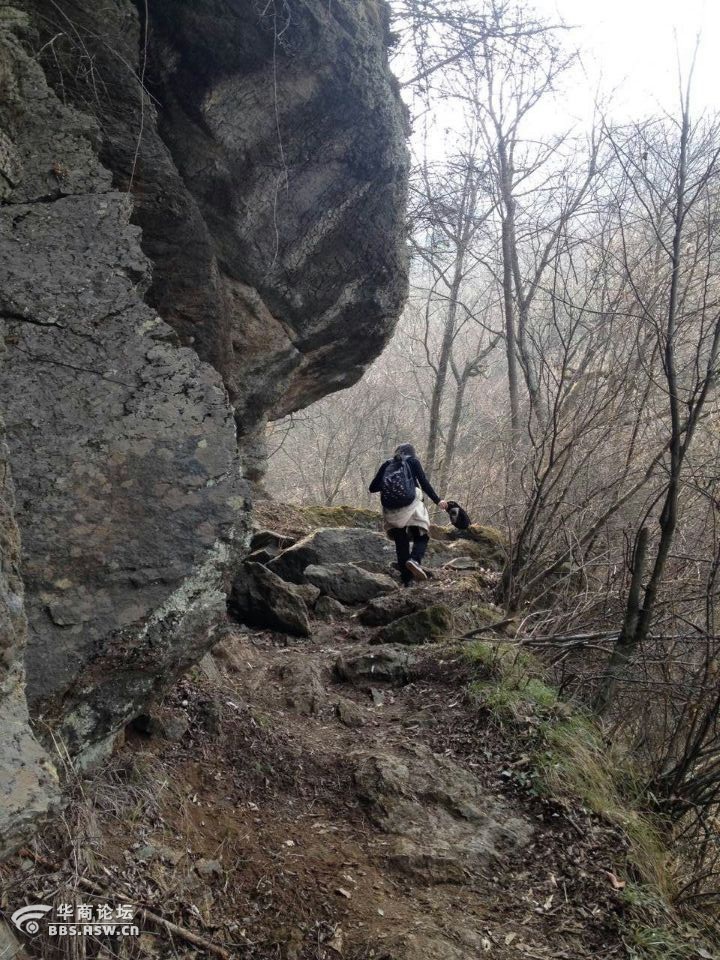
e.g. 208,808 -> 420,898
354,744 -> 532,883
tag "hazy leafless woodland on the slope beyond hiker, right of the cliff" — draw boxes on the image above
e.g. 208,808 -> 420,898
267,0 -> 720,900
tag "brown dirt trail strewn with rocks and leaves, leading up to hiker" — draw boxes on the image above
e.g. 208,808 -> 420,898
0,517 -> 648,960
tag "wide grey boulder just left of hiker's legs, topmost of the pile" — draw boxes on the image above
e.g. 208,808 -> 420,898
268,527 -> 395,583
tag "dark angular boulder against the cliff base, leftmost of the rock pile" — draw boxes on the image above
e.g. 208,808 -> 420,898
228,563 -> 310,637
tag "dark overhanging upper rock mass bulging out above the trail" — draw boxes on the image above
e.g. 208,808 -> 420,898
25,0 -> 408,477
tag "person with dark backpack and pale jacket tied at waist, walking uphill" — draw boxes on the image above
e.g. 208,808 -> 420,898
370,443 -> 447,587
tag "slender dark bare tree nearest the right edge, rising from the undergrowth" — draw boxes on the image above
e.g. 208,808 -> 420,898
596,91 -> 720,709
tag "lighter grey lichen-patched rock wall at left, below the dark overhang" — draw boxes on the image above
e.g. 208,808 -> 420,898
0,8 -> 245,758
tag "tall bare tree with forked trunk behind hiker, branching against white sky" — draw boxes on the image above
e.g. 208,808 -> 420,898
466,7 -> 599,428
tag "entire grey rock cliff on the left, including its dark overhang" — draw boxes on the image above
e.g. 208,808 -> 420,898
0,0 -> 406,856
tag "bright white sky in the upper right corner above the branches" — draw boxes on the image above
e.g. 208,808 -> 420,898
533,0 -> 720,120
